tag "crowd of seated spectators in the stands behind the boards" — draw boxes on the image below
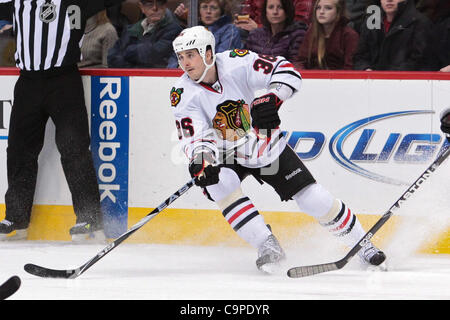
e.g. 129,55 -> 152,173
0,0 -> 450,72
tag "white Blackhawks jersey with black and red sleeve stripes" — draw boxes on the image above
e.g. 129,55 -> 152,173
170,49 -> 301,168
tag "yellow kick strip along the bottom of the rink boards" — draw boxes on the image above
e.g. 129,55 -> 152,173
0,204 -> 450,254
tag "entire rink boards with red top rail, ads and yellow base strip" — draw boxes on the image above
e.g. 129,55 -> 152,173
0,69 -> 450,253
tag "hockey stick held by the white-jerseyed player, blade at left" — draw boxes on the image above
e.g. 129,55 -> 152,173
24,178 -> 195,279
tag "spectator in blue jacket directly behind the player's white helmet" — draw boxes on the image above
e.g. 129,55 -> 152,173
168,0 -> 243,68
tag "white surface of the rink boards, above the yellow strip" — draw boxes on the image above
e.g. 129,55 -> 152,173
0,76 -> 450,214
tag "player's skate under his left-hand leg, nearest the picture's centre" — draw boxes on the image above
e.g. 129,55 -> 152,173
256,234 -> 286,273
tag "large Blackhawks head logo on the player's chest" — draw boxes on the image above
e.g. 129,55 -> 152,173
213,100 -> 251,141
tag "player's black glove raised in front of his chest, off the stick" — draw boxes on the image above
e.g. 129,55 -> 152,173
251,93 -> 283,137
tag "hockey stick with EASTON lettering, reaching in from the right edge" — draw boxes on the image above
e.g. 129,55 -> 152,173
287,142 -> 450,278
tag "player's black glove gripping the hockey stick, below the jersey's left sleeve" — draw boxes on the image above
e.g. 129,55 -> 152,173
189,152 -> 220,187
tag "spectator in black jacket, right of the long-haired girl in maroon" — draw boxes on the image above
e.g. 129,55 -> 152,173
354,0 -> 431,71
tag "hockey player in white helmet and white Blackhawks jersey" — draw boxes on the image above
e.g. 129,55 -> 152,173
170,26 -> 386,271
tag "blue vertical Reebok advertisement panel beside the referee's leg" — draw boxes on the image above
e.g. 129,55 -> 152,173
91,76 -> 130,238
